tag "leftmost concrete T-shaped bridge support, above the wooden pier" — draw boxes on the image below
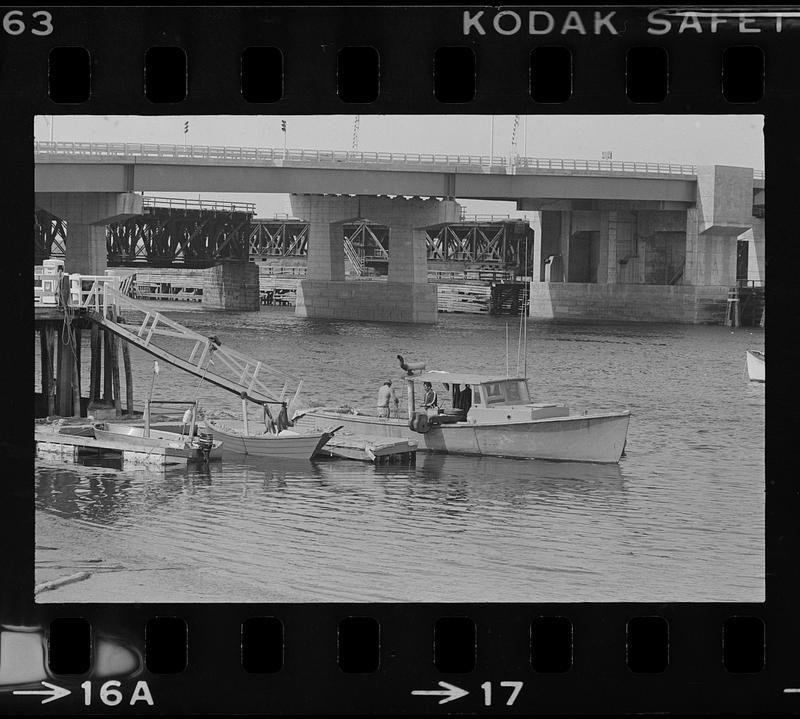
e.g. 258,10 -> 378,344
36,192 -> 142,275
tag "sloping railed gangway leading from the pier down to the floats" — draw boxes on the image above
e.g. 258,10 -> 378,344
80,281 -> 303,404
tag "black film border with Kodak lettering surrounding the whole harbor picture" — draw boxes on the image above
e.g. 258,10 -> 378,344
0,2 -> 800,713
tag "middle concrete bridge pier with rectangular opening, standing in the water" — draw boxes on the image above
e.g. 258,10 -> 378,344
291,195 -> 460,324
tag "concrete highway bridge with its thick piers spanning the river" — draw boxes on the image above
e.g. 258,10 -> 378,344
35,142 -> 764,322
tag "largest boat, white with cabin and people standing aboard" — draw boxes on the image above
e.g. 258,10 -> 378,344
293,362 -> 630,463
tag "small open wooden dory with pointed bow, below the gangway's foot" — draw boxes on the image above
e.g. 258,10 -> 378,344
205,419 -> 333,459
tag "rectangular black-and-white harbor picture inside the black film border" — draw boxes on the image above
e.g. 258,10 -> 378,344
31,114 -> 766,604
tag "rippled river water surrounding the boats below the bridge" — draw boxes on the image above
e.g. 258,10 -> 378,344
36,306 -> 765,602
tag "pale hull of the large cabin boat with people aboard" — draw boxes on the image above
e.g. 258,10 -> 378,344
295,410 -> 630,462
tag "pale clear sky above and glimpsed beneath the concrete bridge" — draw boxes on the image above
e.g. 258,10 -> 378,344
34,115 -> 764,217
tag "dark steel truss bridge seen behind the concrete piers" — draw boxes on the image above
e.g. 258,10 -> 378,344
39,197 -> 533,274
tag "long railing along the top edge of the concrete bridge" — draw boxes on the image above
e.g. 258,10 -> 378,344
34,141 -> 764,179
